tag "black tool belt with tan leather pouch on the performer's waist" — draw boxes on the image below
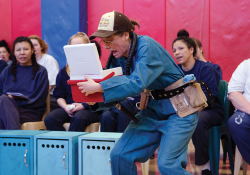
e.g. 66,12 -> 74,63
140,78 -> 214,118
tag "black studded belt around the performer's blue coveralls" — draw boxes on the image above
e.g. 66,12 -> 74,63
150,80 -> 214,106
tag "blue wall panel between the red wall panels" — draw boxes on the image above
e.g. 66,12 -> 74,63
41,0 -> 87,68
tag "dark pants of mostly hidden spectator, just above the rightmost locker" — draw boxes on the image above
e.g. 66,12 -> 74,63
100,100 -> 140,133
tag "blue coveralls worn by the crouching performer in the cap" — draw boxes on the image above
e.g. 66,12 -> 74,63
100,36 -> 198,175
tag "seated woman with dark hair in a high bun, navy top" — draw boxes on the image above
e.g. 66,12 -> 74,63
172,30 -> 224,175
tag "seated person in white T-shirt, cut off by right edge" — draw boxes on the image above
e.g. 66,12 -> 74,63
228,59 -> 250,164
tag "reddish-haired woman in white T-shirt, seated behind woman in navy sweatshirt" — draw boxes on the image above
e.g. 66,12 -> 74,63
29,35 -> 59,111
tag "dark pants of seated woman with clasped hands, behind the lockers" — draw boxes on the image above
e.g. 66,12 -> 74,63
44,108 -> 100,132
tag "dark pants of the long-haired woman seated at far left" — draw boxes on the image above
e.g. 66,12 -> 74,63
0,95 -> 41,130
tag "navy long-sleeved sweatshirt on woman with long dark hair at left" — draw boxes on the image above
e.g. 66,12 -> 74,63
0,64 -> 49,116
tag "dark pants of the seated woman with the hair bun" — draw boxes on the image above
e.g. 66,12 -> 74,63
192,108 -> 224,166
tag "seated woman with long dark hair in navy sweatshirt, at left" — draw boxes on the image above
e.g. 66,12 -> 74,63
0,37 -> 49,130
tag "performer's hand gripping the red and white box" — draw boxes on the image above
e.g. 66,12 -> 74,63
77,76 -> 103,96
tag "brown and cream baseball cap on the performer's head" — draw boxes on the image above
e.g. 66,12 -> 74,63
89,11 -> 133,40
